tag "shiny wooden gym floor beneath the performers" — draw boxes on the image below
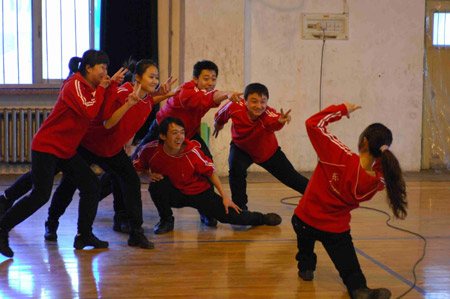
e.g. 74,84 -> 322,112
0,175 -> 450,298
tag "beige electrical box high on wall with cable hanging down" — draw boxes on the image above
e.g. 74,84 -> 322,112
301,13 -> 348,40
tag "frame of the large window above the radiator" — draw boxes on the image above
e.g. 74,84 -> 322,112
0,0 -> 96,90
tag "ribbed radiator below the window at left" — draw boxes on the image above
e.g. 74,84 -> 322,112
0,107 -> 53,163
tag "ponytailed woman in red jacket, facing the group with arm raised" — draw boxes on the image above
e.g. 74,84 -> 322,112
292,103 -> 407,298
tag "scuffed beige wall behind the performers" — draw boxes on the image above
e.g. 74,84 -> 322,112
164,0 -> 425,175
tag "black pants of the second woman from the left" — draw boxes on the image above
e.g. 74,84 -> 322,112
48,146 -> 143,229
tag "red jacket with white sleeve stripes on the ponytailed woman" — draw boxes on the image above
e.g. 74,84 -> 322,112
295,104 -> 384,233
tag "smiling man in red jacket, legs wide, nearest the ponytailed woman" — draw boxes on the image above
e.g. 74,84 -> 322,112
213,83 -> 308,210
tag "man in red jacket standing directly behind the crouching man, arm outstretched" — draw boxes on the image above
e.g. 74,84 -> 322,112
132,60 -> 240,227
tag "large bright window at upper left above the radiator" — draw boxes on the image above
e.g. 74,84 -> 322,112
0,0 -> 101,87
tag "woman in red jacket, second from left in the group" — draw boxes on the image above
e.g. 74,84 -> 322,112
40,59 -> 178,249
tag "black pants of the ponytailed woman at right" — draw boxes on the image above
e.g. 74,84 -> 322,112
292,214 -> 367,294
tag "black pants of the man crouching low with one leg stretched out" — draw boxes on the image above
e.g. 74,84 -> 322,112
148,178 -> 264,225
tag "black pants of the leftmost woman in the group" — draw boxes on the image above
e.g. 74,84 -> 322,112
0,151 -> 100,234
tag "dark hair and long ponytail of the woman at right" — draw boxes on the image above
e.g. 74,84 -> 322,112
359,123 -> 408,219
